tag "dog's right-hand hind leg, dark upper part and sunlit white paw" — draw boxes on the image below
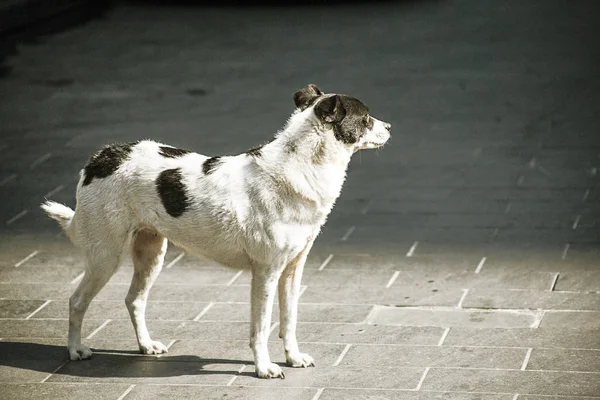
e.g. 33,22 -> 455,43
125,229 -> 167,354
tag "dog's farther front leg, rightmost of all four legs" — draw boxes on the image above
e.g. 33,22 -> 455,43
279,242 -> 315,368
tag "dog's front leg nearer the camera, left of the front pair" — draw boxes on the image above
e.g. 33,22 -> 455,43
250,267 -> 285,379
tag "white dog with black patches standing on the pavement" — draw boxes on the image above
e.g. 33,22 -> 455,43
41,84 -> 391,378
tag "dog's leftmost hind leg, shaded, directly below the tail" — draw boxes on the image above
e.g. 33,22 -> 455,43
68,235 -> 127,360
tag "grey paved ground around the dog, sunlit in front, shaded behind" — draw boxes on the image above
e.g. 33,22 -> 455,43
0,0 -> 600,400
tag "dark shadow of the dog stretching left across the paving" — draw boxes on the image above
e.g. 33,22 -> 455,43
0,341 -> 255,378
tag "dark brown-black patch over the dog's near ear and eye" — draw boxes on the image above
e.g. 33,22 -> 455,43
315,95 -> 373,144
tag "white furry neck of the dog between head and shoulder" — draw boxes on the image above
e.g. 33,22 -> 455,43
258,110 -> 352,208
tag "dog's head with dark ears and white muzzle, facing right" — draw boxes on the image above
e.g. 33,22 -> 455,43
294,84 -> 392,151
